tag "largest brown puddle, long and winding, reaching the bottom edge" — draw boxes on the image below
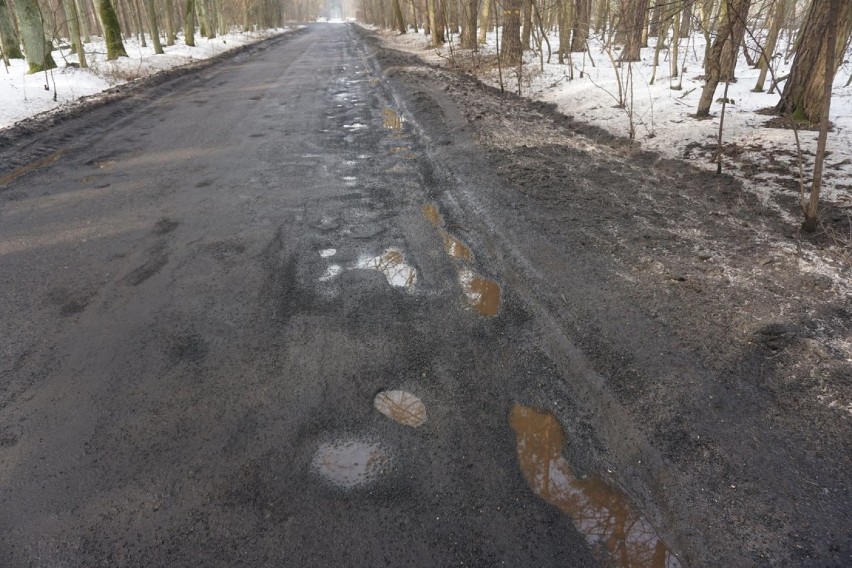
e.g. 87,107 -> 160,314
509,403 -> 681,568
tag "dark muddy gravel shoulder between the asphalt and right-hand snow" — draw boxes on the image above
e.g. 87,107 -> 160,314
364,28 -> 852,566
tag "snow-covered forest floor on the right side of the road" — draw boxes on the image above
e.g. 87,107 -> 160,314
377,24 -> 852,216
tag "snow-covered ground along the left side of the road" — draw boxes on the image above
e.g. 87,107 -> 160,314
0,29 -> 296,129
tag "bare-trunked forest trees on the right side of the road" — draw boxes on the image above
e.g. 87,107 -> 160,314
359,0 -> 852,231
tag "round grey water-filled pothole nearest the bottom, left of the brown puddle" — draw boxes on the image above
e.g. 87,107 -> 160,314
311,440 -> 390,489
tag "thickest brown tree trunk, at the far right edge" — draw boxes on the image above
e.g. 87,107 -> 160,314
775,0 -> 852,123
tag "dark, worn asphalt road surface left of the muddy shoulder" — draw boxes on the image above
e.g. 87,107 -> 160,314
0,25 -> 612,567
